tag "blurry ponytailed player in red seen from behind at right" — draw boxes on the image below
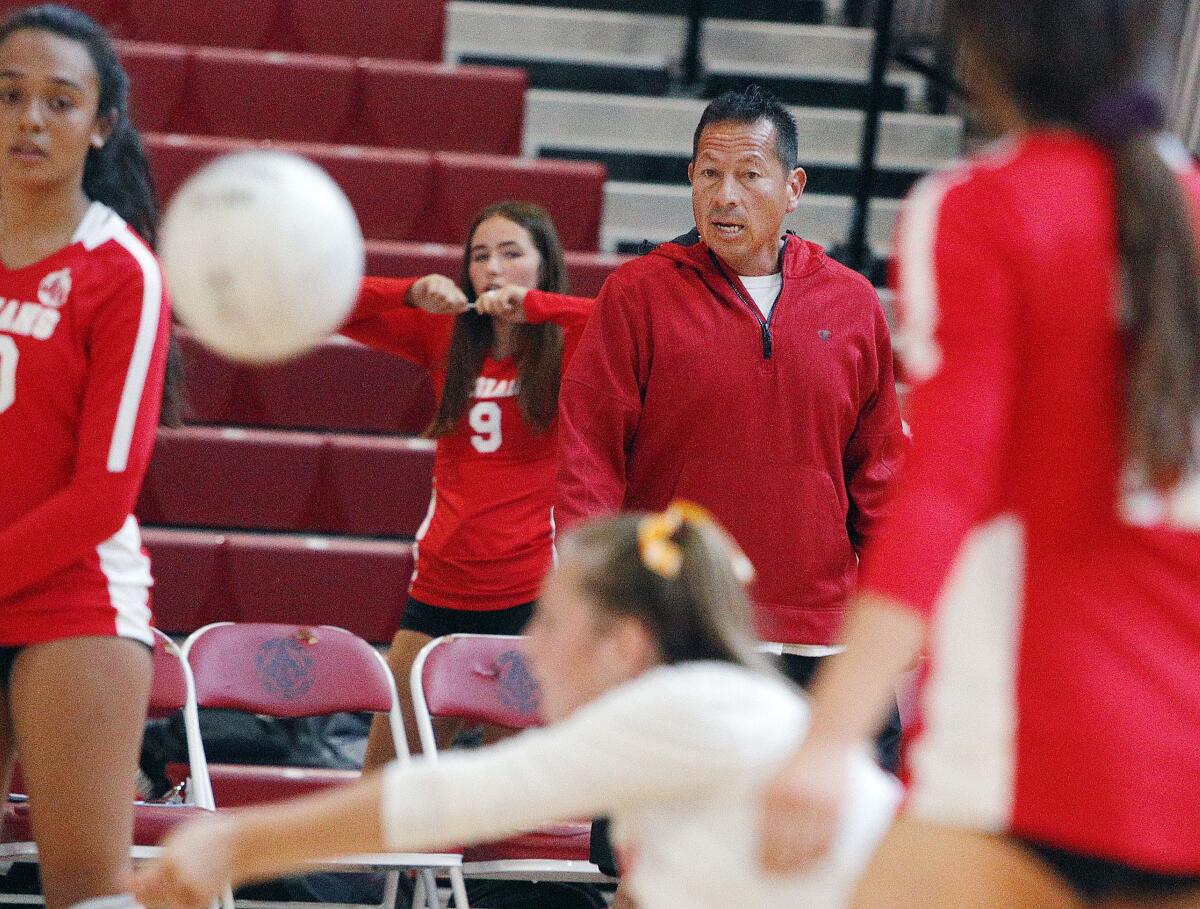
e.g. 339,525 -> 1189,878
766,0 -> 1200,909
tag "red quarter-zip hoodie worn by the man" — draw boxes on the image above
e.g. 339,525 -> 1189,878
556,234 -> 907,644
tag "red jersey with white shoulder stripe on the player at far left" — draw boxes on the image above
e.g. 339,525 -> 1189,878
0,203 -> 170,646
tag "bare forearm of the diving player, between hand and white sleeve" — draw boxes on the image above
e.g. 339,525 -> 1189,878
233,775 -> 385,884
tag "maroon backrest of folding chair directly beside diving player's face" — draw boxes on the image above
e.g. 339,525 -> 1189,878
413,634 -> 544,729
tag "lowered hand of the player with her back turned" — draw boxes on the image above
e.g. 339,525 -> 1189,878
760,739 -> 852,874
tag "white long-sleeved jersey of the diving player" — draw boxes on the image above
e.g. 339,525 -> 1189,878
382,662 -> 900,909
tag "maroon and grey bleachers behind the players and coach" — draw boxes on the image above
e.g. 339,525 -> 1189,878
23,0 -> 960,643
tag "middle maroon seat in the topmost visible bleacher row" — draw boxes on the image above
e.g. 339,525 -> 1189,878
127,0 -> 280,49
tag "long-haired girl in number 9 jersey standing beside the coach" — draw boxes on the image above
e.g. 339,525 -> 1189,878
342,201 -> 592,769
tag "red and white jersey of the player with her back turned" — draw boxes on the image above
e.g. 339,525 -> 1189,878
863,132 -> 1200,874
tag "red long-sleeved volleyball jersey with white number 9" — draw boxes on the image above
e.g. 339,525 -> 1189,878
342,278 -> 592,610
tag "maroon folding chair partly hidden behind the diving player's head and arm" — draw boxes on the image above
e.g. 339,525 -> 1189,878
410,634 -> 614,883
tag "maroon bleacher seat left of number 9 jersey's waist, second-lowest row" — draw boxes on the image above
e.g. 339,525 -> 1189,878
326,435 -> 433,536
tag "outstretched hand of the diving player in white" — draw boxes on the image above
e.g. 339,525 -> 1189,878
133,818 -> 236,909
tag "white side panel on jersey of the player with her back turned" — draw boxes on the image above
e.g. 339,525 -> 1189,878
910,514 -> 1025,831
